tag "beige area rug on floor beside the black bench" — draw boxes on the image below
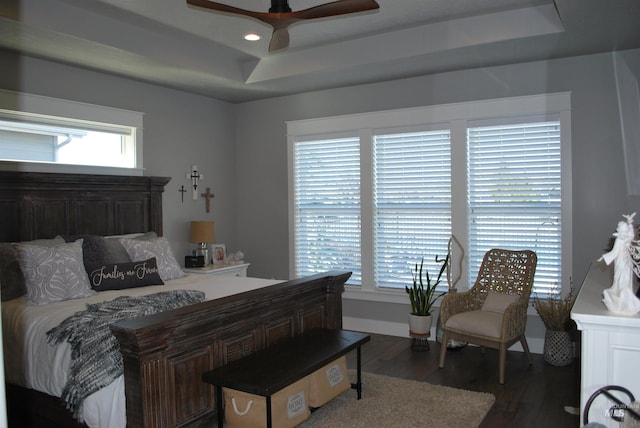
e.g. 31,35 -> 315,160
298,372 -> 495,428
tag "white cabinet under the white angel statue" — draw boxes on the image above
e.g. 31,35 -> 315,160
571,261 -> 640,427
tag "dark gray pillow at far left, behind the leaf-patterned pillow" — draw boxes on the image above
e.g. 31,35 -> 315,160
0,236 -> 64,302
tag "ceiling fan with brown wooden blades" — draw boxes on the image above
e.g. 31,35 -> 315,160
187,0 -> 380,52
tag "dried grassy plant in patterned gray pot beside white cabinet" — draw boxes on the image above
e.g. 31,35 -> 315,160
533,288 -> 576,366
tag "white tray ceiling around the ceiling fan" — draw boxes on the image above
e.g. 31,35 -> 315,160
0,0 -> 640,102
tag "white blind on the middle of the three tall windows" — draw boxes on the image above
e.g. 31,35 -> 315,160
373,130 -> 451,288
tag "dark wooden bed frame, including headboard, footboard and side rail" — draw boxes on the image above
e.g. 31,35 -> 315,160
0,171 -> 351,428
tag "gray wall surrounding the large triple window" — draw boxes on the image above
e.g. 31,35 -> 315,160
235,50 -> 640,344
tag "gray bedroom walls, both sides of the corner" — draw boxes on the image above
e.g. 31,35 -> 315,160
0,46 -> 640,348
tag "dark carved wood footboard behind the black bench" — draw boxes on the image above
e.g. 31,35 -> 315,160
112,272 -> 351,427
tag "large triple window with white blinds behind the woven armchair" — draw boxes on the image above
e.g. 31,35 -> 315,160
287,94 -> 571,301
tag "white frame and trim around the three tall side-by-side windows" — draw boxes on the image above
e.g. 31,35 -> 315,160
286,92 -> 573,303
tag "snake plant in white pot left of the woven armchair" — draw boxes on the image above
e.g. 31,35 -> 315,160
405,254 -> 449,339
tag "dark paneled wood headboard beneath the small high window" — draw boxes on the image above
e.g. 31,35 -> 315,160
0,171 -> 170,242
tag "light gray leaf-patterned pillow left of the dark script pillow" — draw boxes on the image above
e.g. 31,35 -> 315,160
14,239 -> 95,305
